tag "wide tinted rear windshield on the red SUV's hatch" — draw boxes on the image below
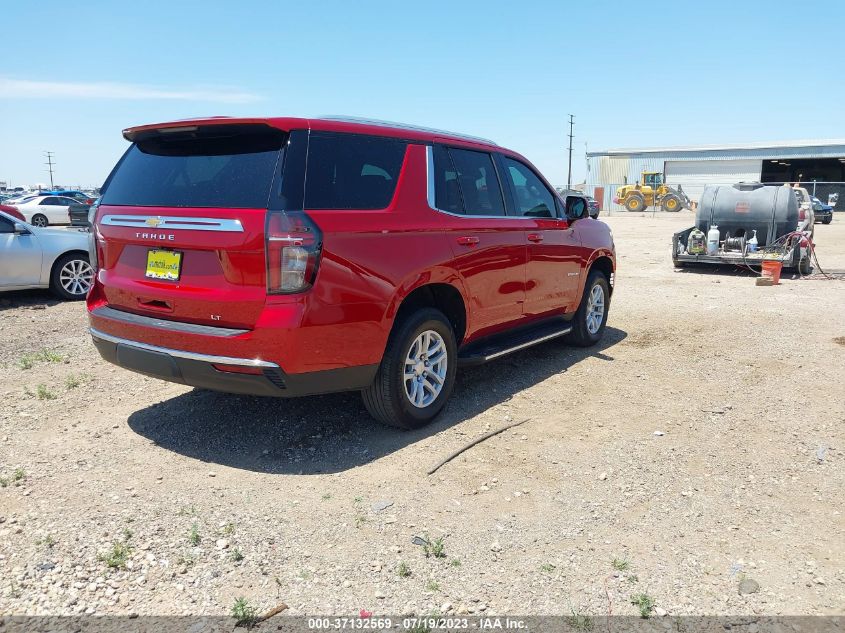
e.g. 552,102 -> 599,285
102,125 -> 287,208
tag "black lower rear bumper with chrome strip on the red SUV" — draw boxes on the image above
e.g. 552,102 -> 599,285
90,328 -> 378,397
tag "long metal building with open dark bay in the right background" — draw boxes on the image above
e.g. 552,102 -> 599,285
587,139 -> 845,208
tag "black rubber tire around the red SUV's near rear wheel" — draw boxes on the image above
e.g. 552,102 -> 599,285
362,308 -> 458,429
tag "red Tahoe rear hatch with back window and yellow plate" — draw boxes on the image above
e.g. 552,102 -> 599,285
97,123 -> 287,328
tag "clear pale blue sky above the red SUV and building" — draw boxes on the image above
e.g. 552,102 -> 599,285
0,0 -> 845,185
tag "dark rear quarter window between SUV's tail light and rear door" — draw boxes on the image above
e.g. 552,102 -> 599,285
305,132 -> 407,209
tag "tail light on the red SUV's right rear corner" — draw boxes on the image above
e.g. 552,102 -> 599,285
265,211 -> 323,294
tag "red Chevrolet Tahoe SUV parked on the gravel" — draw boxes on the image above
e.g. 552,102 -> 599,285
88,118 -> 615,428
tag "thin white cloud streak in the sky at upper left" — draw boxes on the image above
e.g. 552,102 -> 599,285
0,77 -> 261,103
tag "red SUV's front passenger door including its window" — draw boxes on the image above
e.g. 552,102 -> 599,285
500,155 -> 581,316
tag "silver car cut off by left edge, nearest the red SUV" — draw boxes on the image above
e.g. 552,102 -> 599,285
0,211 -> 94,299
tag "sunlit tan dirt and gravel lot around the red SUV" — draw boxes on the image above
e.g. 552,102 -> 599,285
0,213 -> 845,615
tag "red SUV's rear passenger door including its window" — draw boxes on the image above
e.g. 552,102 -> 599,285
431,144 -> 529,335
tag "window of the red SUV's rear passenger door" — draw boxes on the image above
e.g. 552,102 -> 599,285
434,145 -> 505,215
